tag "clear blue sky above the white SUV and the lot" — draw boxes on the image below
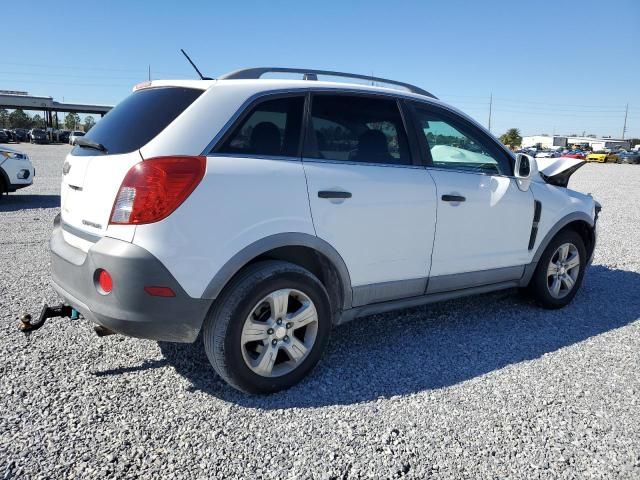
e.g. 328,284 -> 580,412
5,0 -> 640,137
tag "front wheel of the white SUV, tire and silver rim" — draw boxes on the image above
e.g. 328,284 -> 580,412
529,230 -> 587,309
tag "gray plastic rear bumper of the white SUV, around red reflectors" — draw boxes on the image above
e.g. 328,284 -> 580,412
49,218 -> 212,342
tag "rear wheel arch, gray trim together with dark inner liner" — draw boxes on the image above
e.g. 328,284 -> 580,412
202,232 -> 352,318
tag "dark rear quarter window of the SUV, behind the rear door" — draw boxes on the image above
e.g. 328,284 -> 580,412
216,96 -> 304,157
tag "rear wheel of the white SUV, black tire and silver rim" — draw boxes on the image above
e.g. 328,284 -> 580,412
203,260 -> 332,394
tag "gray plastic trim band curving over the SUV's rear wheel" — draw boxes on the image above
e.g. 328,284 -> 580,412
202,232 -> 352,310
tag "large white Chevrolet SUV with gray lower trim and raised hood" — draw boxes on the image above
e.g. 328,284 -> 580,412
51,69 -> 599,393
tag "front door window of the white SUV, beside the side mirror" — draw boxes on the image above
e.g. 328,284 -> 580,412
415,106 -> 511,175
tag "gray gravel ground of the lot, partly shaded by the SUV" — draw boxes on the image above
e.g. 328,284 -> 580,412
0,145 -> 640,479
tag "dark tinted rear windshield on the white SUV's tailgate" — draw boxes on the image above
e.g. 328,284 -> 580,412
75,87 -> 203,155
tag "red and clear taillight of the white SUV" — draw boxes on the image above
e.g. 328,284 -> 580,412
109,156 -> 206,225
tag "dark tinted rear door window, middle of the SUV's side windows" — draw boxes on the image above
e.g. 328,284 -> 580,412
305,94 -> 411,165
